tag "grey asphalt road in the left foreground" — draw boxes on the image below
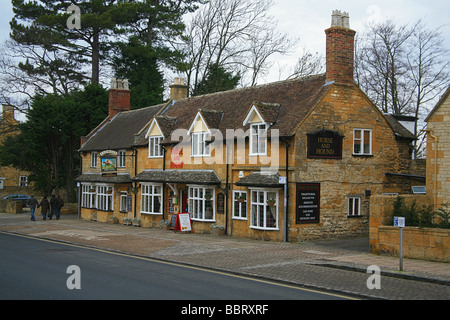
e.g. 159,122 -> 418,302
0,233 -> 352,302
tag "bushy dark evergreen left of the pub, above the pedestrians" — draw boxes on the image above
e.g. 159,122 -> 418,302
0,85 -> 108,200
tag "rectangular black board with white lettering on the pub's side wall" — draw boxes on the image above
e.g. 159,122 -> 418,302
295,183 -> 320,223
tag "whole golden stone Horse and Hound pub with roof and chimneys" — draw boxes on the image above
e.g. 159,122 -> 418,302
77,11 -> 414,241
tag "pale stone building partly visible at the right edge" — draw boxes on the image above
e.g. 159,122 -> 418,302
425,88 -> 450,207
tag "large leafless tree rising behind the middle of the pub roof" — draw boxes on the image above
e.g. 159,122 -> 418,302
184,0 -> 293,91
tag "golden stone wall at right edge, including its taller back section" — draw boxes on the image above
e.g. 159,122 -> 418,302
369,195 -> 450,262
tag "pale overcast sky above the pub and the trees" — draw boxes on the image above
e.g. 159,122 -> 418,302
0,0 -> 450,82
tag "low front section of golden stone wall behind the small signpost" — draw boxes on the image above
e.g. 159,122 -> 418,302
378,226 -> 450,262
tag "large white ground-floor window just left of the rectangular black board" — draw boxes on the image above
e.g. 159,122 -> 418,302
250,189 -> 278,230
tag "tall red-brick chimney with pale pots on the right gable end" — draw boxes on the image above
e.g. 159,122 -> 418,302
325,10 -> 356,84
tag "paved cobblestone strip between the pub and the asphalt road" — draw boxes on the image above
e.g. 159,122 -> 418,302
0,213 -> 450,300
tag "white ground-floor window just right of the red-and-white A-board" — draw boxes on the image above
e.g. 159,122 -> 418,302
188,186 -> 215,221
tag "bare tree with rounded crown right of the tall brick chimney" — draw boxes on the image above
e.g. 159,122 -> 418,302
355,19 -> 450,156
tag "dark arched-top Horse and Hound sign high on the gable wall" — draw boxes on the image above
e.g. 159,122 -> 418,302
308,130 -> 344,159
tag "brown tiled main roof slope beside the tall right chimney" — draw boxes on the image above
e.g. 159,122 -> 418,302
160,75 -> 328,137
